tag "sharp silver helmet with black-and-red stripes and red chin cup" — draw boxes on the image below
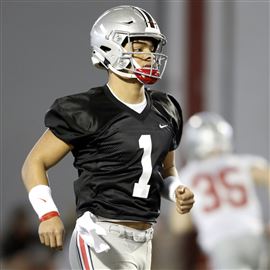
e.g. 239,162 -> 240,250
90,6 -> 167,84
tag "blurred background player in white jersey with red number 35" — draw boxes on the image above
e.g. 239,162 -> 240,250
172,112 -> 269,270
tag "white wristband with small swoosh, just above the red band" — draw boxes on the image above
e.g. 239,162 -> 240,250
28,185 -> 59,220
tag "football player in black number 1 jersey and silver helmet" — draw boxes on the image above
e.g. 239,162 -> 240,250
22,6 -> 194,270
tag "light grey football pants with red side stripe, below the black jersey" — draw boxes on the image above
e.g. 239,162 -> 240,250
69,222 -> 153,270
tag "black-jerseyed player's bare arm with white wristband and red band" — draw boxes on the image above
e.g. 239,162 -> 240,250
21,130 -> 71,249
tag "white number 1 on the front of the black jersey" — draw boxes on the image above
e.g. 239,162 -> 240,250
132,135 -> 152,198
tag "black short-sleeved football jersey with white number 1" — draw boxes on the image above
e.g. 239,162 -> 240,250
45,86 -> 182,221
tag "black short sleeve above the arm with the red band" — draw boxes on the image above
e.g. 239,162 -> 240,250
45,97 -> 87,146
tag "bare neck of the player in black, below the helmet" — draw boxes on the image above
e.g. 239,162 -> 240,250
108,74 -> 145,104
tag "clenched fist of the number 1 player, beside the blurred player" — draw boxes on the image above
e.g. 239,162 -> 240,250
175,186 -> 194,214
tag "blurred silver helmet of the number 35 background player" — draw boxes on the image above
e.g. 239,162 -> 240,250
182,112 -> 233,161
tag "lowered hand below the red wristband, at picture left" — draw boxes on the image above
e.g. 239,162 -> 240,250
38,217 -> 65,250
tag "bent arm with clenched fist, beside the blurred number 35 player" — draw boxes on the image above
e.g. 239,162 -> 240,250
162,151 -> 194,214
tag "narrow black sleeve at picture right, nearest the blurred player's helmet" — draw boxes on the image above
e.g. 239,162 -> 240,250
168,95 -> 183,151
